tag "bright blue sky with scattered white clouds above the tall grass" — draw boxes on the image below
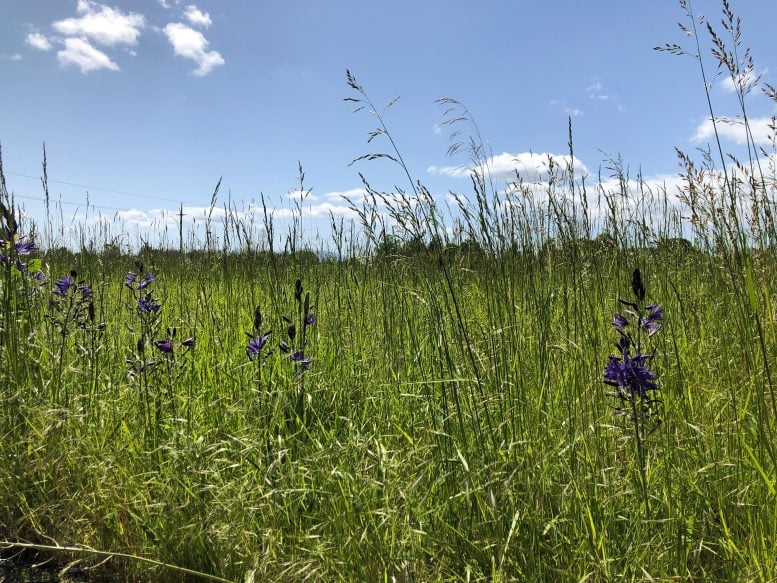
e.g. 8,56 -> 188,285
0,0 -> 777,249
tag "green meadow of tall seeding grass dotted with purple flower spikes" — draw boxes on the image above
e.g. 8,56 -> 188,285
0,2 -> 777,582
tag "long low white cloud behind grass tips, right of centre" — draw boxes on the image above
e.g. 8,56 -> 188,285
427,152 -> 588,182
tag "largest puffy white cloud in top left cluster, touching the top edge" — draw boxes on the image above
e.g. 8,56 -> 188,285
52,0 -> 146,46
